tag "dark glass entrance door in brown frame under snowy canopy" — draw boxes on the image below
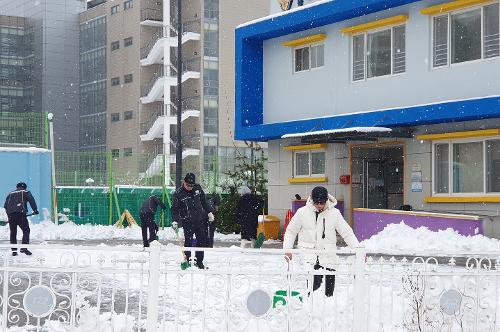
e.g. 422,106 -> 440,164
351,145 -> 404,210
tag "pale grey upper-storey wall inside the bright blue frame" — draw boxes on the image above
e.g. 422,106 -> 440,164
264,1 -> 500,123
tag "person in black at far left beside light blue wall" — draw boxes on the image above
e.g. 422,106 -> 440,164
3,182 -> 38,256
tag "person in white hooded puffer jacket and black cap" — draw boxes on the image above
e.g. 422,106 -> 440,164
283,187 -> 359,297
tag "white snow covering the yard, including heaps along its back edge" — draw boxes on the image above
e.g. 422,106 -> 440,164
0,222 -> 500,332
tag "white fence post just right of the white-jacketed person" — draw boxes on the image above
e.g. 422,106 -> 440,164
353,247 -> 367,332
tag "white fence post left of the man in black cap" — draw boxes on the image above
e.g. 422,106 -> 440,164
146,241 -> 161,332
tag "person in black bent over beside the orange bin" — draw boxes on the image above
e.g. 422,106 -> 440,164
236,186 -> 263,248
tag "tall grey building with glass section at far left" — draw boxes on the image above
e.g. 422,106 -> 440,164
0,0 -> 86,150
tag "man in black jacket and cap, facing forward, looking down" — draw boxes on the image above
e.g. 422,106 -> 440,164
172,173 -> 215,269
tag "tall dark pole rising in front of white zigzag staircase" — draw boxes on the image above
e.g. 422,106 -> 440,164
175,0 -> 182,188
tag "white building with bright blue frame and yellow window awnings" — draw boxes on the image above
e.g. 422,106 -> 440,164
235,0 -> 500,237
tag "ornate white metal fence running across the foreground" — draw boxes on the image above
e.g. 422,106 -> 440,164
0,244 -> 500,332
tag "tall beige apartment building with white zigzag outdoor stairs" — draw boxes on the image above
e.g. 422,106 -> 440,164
80,0 -> 269,185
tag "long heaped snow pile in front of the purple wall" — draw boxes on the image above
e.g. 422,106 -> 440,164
361,223 -> 500,252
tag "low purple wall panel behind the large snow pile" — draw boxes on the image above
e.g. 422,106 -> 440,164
353,211 -> 483,241
